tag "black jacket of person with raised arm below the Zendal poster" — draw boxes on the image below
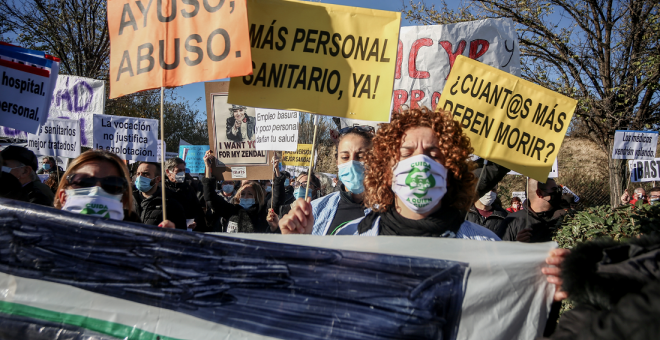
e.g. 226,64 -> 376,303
202,177 -> 279,233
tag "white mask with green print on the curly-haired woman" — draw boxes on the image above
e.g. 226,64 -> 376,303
392,155 -> 447,214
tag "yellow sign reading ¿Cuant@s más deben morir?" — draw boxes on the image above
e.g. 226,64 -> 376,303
438,56 -> 577,182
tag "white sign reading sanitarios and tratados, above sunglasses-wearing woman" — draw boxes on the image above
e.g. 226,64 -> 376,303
28,118 -> 80,158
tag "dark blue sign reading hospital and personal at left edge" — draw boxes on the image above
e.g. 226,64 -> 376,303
0,45 -> 59,133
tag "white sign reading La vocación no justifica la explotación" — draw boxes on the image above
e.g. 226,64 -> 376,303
94,115 -> 158,162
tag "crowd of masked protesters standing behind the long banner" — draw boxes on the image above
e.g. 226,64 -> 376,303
0,108 -> 660,334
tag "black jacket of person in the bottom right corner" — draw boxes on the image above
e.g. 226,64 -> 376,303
551,235 -> 660,340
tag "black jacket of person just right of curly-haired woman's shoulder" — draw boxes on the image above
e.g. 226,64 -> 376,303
499,200 -> 566,243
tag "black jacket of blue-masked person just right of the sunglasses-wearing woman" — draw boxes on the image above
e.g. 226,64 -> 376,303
133,187 -> 187,230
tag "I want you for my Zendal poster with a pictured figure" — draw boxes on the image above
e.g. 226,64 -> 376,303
211,93 -> 268,166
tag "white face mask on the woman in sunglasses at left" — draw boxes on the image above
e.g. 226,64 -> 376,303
62,186 -> 124,221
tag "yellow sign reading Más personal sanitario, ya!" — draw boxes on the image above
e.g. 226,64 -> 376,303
229,0 -> 401,121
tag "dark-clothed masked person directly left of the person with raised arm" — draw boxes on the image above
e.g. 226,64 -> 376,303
165,157 -> 210,232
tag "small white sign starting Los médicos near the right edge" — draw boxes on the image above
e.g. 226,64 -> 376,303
612,130 -> 658,159
